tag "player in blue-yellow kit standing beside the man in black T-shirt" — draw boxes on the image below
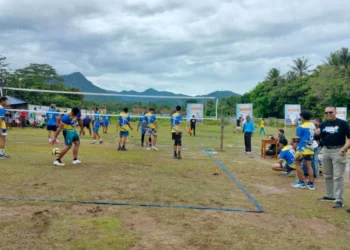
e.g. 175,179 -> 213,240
292,110 -> 316,190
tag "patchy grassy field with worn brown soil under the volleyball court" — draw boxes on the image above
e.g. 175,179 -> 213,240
0,122 -> 350,250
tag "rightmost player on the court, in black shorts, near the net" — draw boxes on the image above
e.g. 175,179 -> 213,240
170,106 -> 182,160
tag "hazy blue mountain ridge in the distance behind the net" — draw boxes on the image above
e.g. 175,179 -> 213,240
61,72 -> 240,102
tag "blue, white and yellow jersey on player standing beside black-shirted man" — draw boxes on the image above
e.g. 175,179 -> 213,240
297,122 -> 316,155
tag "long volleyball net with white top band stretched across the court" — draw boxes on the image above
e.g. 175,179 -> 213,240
0,87 -> 218,121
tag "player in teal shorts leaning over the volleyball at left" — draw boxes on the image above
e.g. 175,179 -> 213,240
52,107 -> 85,166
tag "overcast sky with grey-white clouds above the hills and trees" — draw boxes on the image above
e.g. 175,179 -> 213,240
0,0 -> 350,95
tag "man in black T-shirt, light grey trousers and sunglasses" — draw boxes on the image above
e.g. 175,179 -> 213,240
316,106 -> 350,212
